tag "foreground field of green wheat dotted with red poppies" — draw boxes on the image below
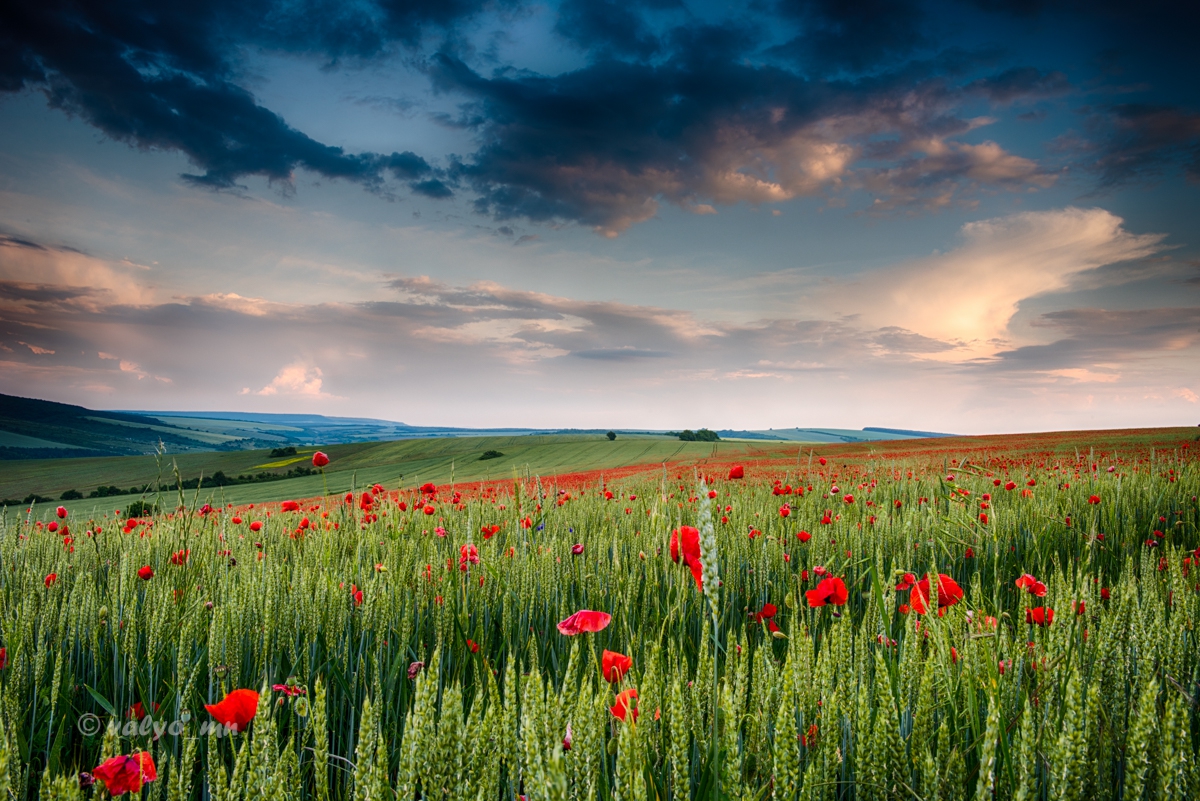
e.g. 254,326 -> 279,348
0,442 -> 1200,801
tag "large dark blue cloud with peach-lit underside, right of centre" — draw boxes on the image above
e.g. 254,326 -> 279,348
431,47 -> 1063,235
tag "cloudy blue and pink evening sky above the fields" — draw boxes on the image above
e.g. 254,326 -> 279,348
0,0 -> 1200,434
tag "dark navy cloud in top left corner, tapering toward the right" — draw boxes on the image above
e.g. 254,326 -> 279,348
0,0 -> 460,191
